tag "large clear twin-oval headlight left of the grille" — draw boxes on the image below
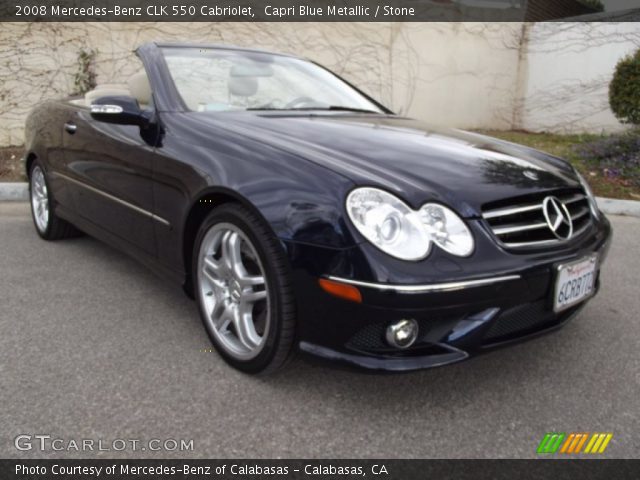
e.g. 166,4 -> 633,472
346,187 -> 474,260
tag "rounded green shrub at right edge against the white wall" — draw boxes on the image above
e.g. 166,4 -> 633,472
609,50 -> 640,125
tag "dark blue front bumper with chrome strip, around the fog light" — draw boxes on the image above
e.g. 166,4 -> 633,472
287,219 -> 611,371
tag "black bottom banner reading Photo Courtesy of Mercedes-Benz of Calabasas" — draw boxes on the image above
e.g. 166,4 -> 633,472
0,459 -> 640,480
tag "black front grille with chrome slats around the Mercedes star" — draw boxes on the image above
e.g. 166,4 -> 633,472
482,191 -> 591,249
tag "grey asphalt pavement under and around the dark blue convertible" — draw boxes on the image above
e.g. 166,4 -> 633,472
0,204 -> 640,458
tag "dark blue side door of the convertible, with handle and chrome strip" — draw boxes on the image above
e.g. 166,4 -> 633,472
62,70 -> 156,256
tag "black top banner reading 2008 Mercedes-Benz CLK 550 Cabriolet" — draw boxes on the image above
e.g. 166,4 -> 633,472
0,0 -> 640,22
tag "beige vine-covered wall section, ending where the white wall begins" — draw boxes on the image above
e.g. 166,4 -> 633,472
0,22 -> 520,145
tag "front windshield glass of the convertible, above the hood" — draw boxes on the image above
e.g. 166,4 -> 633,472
162,48 -> 384,113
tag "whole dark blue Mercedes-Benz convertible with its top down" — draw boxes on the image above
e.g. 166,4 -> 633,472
25,43 -> 611,373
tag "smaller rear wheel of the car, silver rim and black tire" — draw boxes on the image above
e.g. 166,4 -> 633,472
29,160 -> 80,240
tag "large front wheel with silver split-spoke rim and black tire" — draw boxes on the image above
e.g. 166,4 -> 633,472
191,203 -> 295,374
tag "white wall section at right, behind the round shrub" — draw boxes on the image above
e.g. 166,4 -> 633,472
514,22 -> 640,133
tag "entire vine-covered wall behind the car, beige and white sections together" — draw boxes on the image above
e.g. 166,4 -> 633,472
0,22 -> 640,146
